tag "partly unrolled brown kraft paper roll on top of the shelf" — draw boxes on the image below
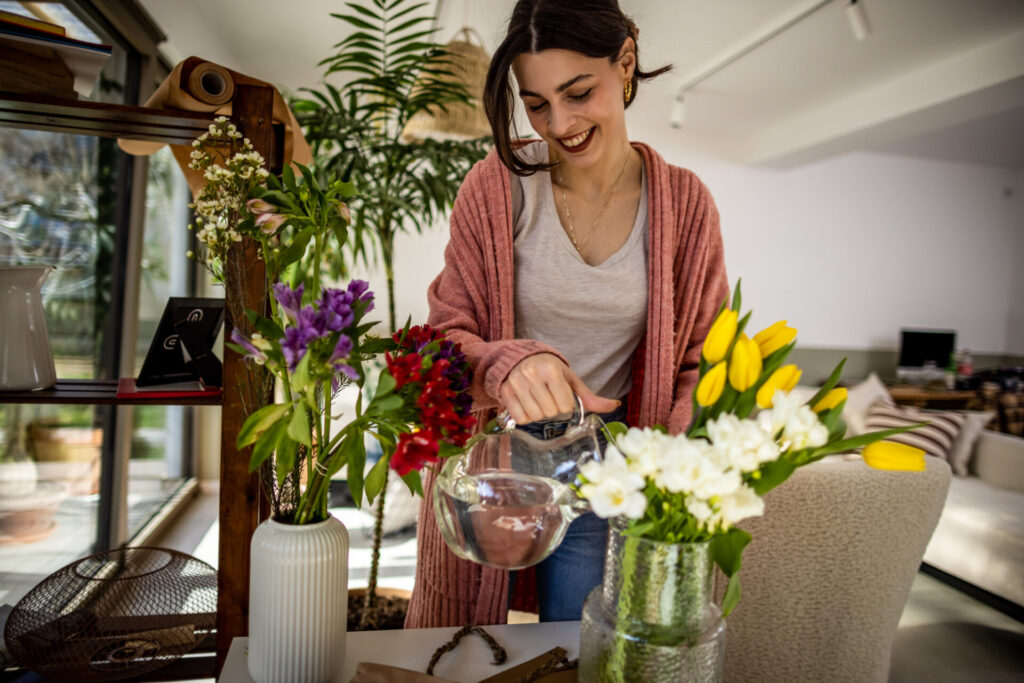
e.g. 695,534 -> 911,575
118,56 -> 312,197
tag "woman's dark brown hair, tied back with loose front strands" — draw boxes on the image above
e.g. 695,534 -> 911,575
483,0 -> 672,175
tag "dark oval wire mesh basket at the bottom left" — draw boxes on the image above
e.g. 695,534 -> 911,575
4,547 -> 217,681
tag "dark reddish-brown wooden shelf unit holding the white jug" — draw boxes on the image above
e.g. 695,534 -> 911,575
0,84 -> 280,680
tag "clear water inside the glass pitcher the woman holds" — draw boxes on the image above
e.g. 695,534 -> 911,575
434,471 -> 579,569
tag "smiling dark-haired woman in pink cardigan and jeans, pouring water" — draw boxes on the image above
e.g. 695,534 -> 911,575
406,0 -> 728,628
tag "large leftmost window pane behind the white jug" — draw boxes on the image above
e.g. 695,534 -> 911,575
0,1 -> 127,604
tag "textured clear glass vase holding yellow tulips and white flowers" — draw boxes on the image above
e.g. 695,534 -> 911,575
580,524 -> 725,683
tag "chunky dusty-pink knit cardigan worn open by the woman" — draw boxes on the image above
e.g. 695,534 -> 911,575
406,143 -> 728,629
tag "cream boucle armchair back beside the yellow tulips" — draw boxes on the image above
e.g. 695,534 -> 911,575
725,457 -> 950,683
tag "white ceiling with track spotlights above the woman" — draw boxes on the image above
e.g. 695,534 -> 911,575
141,0 -> 1024,169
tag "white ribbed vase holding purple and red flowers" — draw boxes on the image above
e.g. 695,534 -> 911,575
248,517 -> 348,683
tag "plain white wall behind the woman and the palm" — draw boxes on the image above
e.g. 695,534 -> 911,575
369,134 -> 1024,353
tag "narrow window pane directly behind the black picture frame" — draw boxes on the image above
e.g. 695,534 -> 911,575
128,147 -> 191,537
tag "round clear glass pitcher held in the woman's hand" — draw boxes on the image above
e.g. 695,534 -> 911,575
434,398 -> 604,569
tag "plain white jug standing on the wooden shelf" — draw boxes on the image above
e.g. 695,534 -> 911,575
0,265 -> 57,391
